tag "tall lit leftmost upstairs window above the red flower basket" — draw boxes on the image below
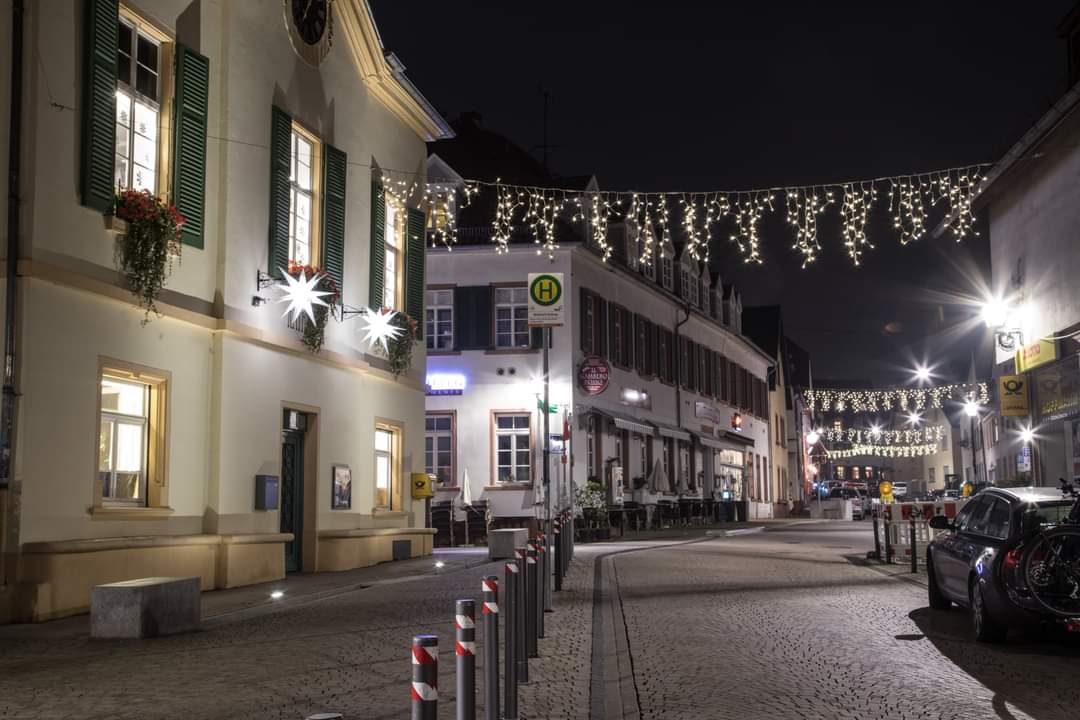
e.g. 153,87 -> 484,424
113,9 -> 167,194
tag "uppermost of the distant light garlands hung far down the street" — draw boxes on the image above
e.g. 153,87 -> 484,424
802,382 -> 990,412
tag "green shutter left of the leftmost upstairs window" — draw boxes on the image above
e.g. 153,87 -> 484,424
79,0 -> 120,213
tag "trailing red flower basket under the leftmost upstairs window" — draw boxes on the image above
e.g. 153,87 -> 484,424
112,190 -> 184,325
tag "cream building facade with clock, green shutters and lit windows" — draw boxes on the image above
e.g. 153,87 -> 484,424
0,0 -> 449,622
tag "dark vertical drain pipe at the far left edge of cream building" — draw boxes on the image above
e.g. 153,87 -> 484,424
0,0 -> 24,500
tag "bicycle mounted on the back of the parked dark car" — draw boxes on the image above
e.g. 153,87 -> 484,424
1021,480 -> 1080,621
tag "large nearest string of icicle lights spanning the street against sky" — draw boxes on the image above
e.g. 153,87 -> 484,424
410,164 -> 989,268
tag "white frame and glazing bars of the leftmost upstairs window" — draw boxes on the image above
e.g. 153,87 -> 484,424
112,6 -> 171,194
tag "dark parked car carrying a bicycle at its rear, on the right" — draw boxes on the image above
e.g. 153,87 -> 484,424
927,487 -> 1072,642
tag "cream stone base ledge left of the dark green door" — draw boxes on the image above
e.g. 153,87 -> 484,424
0,533 -> 292,623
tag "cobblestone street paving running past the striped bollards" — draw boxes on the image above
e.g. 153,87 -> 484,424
0,522 -> 1080,720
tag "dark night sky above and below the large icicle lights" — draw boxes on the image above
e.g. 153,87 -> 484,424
374,0 -> 1076,382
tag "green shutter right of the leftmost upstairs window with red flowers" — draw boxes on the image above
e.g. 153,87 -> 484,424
173,44 -> 210,248
